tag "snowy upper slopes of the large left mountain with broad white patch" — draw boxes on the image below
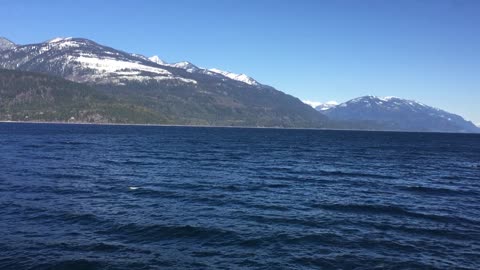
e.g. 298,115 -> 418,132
0,38 -> 196,85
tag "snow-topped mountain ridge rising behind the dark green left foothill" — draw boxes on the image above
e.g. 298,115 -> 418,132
0,37 -> 478,132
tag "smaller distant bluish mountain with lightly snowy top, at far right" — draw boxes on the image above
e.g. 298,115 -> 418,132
318,96 -> 480,132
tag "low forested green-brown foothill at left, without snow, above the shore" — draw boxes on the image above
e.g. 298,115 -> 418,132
0,69 -> 170,124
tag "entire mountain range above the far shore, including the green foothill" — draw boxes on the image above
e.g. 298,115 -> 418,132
0,35 -> 478,132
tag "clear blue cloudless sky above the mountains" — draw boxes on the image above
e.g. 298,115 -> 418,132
0,0 -> 480,123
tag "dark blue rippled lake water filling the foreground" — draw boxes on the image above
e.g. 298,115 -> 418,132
0,123 -> 480,270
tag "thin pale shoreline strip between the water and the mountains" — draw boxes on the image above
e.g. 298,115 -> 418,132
0,120 -> 480,135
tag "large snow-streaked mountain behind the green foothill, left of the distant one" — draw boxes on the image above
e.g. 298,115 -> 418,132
0,38 -> 327,128
